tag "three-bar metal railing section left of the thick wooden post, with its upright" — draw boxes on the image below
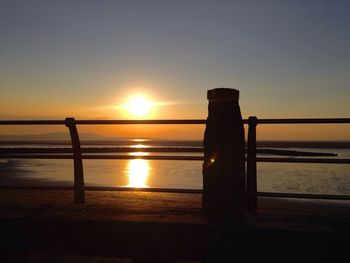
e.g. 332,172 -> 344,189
0,118 -> 206,203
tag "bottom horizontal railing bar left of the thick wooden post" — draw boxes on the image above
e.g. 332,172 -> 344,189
0,185 -> 203,194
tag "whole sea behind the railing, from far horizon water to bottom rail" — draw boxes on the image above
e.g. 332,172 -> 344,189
0,139 -> 350,195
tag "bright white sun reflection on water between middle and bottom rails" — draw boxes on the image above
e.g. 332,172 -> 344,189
127,159 -> 151,188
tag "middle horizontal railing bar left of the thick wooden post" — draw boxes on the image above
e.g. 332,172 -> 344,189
0,154 -> 204,161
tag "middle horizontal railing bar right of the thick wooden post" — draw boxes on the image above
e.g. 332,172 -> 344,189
256,157 -> 350,164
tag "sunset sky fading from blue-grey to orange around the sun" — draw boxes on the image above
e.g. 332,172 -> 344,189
0,0 -> 350,140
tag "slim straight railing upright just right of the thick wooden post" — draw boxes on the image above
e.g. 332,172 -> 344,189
247,117 -> 258,213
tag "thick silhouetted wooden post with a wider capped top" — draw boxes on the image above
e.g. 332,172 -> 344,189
202,88 -> 247,222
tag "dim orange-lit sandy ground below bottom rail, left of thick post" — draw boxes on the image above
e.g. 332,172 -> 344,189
0,190 -> 205,223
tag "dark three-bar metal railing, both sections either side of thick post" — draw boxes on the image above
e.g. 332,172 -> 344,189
0,117 -> 350,212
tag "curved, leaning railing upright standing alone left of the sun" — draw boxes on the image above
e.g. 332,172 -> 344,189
65,118 -> 85,204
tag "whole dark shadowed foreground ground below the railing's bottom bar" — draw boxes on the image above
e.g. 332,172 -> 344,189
0,190 -> 350,262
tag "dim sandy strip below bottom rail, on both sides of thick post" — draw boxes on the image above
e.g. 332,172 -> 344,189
0,190 -> 350,230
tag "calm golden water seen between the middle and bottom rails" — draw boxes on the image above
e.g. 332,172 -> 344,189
0,142 -> 350,194
